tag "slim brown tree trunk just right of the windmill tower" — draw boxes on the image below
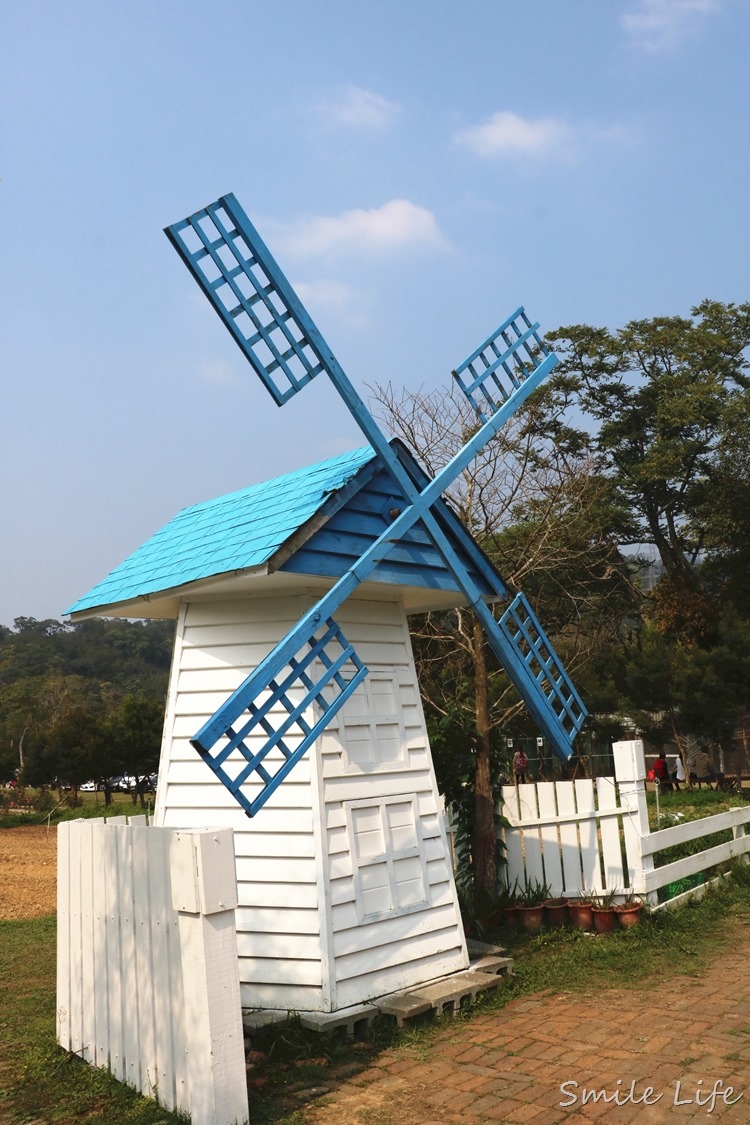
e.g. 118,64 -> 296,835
472,618 -> 497,899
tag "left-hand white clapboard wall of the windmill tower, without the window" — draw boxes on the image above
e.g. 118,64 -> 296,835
156,596 -> 322,1009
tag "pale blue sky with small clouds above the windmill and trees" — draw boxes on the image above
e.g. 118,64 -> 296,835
0,0 -> 750,624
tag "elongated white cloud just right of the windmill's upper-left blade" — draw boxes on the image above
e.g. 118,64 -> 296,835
281,199 -> 445,257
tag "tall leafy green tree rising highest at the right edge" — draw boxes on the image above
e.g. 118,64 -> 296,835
546,300 -> 750,637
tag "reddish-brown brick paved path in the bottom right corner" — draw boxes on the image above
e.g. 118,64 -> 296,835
304,924 -> 750,1125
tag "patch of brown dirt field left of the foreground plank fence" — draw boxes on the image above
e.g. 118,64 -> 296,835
0,826 -> 57,920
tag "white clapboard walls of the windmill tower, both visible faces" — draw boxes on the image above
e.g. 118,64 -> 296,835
156,594 -> 468,1011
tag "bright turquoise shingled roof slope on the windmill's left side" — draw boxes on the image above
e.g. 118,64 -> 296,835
64,446 -> 376,613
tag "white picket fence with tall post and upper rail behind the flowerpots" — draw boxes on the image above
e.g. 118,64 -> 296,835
498,741 -> 750,906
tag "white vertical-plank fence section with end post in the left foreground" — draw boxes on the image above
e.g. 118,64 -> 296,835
57,817 -> 249,1125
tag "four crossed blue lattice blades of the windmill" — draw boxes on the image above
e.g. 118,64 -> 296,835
165,195 -> 587,817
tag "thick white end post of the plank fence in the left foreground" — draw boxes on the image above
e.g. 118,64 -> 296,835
170,828 -> 249,1125
